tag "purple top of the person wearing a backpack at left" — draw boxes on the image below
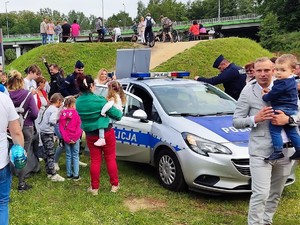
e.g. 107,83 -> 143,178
9,89 -> 39,126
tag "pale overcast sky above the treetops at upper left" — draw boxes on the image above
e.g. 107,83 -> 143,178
0,0 -> 188,19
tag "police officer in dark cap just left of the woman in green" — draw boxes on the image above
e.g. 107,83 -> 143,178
61,60 -> 84,97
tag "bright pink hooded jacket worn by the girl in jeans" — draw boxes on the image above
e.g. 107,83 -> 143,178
59,109 -> 82,144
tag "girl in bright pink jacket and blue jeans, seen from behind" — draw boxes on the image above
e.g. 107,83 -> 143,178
59,96 -> 82,181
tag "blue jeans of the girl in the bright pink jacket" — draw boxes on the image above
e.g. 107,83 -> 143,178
65,140 -> 80,177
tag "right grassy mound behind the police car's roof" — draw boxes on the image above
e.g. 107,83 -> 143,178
154,37 -> 272,77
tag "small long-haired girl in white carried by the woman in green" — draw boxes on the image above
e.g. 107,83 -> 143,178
94,80 -> 126,146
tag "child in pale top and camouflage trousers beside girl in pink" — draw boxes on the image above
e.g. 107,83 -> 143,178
39,93 -> 65,181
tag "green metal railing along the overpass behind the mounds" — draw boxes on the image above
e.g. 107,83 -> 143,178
4,14 -> 261,39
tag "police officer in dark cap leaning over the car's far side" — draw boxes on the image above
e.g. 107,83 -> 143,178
194,55 -> 247,100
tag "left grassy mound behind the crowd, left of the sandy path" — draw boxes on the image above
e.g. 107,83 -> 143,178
8,42 -> 140,78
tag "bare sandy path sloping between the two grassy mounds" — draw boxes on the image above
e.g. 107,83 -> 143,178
150,41 -> 199,70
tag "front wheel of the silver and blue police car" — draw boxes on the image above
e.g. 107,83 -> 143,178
156,149 -> 186,191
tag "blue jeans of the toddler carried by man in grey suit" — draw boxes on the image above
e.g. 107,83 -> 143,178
270,108 -> 300,153
